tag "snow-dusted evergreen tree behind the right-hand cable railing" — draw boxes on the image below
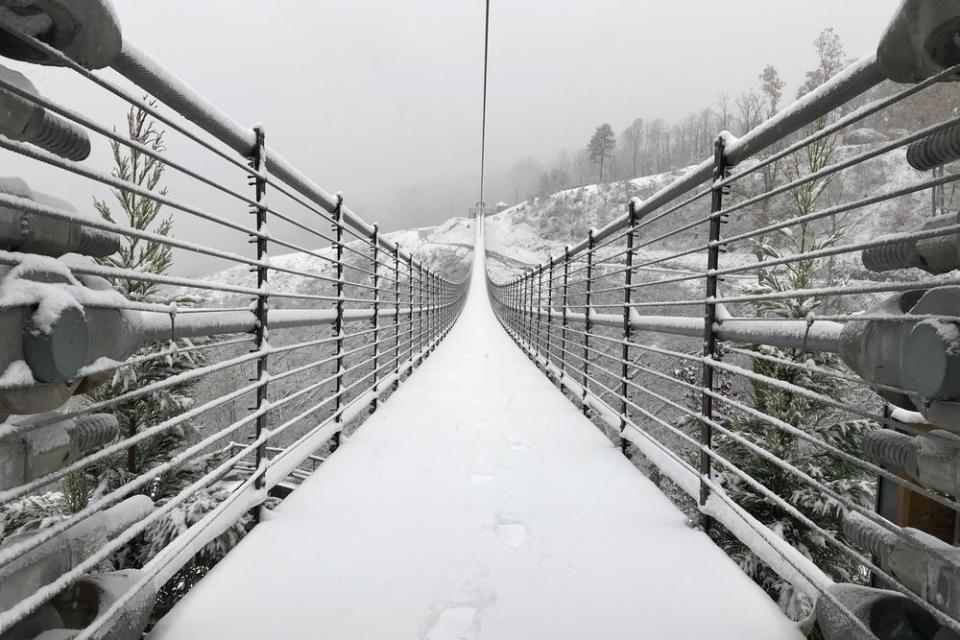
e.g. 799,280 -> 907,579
714,29 -> 877,618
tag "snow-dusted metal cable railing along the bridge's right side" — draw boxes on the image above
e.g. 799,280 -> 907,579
489,2 -> 960,638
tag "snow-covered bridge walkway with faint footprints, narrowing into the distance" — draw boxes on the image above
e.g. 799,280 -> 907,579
151,230 -> 801,640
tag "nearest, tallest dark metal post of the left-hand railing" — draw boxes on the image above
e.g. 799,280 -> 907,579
250,126 -> 270,522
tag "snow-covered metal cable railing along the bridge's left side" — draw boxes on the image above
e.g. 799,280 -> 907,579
0,5 -> 470,639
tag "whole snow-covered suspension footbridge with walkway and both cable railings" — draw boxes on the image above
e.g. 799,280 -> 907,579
0,0 -> 960,640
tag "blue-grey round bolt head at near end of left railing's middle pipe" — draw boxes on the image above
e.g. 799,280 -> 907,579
23,307 -> 89,382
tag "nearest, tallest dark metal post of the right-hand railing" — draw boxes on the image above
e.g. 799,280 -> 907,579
700,135 -> 727,530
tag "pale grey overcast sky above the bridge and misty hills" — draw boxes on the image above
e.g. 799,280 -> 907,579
0,0 -> 898,271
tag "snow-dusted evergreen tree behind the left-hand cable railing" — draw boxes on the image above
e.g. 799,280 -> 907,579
86,102 -> 252,618
